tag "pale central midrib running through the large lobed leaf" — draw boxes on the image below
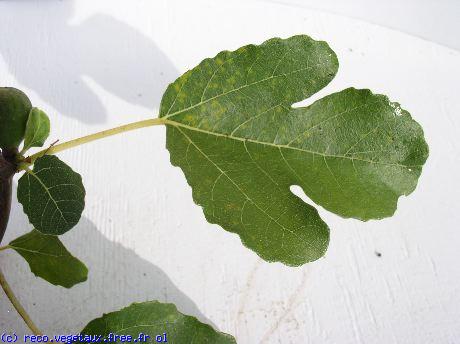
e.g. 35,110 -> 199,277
164,119 -> 420,169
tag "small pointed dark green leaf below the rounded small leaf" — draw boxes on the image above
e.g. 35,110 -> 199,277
8,230 -> 88,288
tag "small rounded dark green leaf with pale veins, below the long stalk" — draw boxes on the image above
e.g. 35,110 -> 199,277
18,155 -> 85,235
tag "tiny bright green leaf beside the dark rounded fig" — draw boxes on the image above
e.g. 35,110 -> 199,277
23,107 -> 50,151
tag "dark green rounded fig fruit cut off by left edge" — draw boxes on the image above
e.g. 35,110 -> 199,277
0,87 -> 32,150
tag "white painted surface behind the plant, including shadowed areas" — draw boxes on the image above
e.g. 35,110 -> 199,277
0,0 -> 460,344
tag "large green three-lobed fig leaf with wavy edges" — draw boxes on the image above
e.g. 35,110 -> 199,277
160,36 -> 428,265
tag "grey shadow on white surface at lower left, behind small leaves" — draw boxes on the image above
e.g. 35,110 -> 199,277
0,185 -> 217,336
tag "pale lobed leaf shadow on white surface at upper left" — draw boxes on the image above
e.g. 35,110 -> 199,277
0,0 -> 178,123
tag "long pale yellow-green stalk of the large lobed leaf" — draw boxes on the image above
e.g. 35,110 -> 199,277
27,118 -> 165,163
